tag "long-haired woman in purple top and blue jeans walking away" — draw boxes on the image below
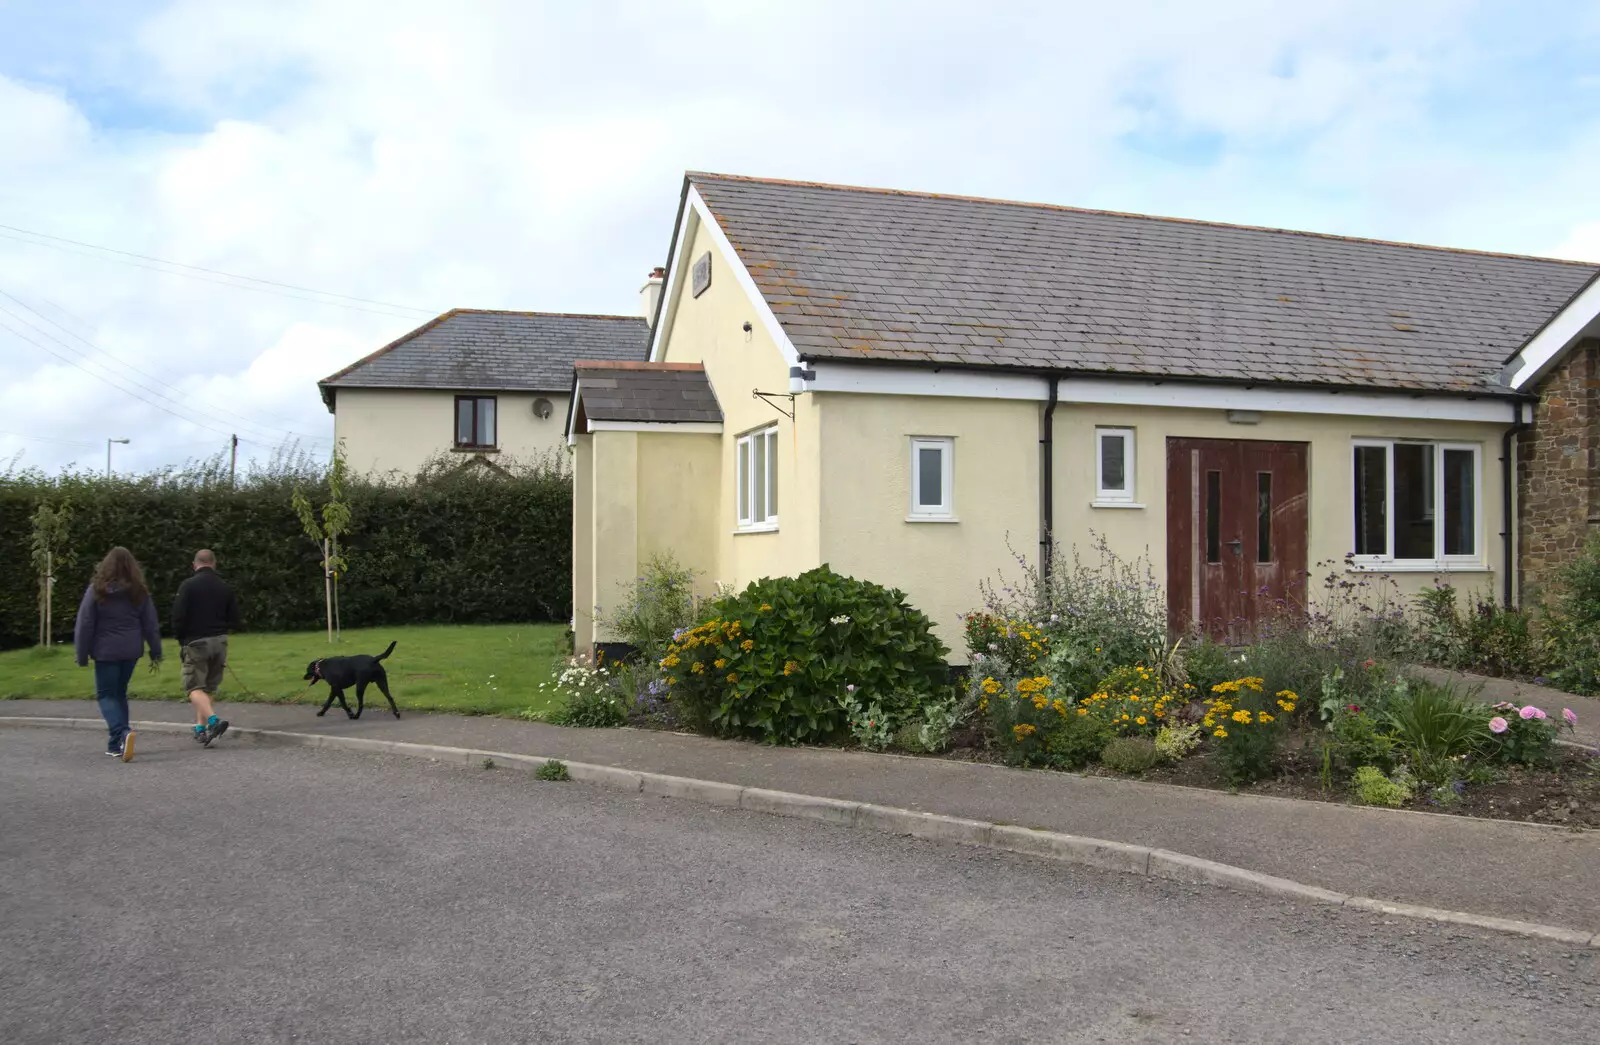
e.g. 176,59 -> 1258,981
74,547 -> 162,762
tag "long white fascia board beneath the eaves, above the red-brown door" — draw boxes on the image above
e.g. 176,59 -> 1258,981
805,362 -> 1517,424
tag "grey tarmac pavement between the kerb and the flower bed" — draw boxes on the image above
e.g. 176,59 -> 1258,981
0,701 -> 1600,931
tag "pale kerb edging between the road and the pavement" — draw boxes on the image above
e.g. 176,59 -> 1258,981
0,715 -> 1600,947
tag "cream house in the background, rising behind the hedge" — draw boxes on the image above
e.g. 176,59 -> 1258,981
317,292 -> 661,477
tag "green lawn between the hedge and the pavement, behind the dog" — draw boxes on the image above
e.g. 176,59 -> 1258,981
0,624 -> 566,715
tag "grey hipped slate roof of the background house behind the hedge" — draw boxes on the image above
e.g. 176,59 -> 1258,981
318,309 -> 650,410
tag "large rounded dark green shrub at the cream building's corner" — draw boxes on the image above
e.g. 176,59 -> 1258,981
661,565 -> 947,744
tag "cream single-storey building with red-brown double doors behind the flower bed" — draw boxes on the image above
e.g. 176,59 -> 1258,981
566,174 -> 1600,656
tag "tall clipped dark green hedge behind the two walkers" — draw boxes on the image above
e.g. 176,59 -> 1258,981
0,460 -> 573,648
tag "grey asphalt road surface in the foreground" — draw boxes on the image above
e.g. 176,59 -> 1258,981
0,730 -> 1600,1045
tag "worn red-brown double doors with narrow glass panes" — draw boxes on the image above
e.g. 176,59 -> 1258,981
1166,438 -> 1306,643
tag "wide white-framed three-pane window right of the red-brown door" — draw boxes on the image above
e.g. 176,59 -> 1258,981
1354,442 -> 1478,563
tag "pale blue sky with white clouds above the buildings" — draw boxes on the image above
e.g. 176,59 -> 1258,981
0,0 -> 1600,470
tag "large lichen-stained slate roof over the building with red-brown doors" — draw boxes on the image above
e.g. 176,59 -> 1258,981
688,173 -> 1600,392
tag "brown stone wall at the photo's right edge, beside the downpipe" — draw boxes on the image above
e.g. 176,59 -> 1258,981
1517,339 -> 1600,602
